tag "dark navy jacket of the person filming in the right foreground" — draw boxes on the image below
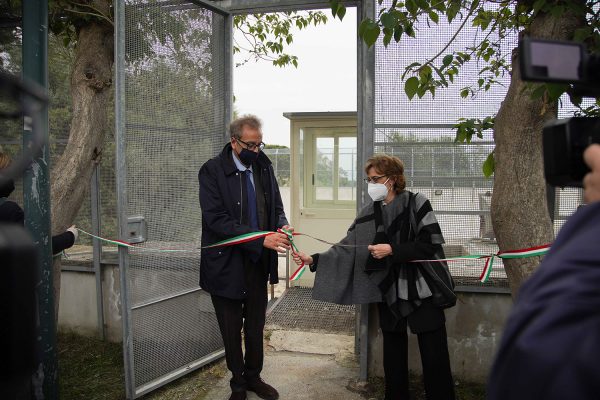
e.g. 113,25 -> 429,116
488,202 -> 600,400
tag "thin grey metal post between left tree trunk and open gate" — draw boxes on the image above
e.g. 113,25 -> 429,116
90,164 -> 104,340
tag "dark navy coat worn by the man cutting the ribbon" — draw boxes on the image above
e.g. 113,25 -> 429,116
198,144 -> 288,299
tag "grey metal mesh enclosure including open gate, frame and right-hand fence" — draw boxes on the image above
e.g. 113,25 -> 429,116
115,0 -> 581,398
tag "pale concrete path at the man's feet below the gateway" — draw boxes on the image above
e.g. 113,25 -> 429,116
206,330 -> 364,400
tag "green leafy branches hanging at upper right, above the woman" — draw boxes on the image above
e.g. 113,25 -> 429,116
330,0 -> 600,176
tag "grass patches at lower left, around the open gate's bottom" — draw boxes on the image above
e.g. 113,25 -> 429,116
57,332 -> 227,400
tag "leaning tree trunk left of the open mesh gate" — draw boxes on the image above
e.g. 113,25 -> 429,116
51,10 -> 114,318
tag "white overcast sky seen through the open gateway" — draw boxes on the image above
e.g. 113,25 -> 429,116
233,8 -> 357,146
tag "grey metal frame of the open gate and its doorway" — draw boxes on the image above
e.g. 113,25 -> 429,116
114,0 -> 375,399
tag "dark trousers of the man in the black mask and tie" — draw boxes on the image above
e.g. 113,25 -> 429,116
211,263 -> 267,392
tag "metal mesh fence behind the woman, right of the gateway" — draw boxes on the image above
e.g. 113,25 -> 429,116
374,2 -> 581,287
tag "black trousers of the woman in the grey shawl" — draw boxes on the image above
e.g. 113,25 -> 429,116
379,304 -> 455,400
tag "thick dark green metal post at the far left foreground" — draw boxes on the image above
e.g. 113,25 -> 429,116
22,0 -> 58,399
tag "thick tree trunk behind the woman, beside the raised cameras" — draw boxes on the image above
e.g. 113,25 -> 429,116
491,0 -> 585,298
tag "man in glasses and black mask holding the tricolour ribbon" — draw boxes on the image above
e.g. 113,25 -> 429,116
198,115 -> 291,400
